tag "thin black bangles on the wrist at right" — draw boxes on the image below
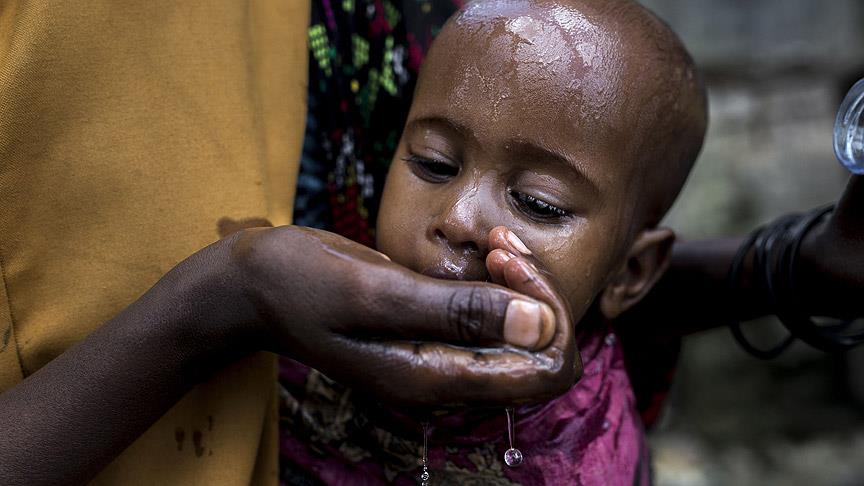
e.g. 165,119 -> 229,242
726,205 -> 864,359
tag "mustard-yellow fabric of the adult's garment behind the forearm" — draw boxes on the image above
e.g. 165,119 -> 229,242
0,0 -> 309,485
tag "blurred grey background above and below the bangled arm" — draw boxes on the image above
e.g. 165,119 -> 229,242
642,0 -> 864,486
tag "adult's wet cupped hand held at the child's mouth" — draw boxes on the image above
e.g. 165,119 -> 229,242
230,226 -> 579,406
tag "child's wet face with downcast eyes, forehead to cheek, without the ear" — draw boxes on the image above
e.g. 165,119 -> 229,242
378,3 -> 676,321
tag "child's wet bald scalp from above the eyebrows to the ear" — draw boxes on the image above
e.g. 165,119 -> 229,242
432,0 -> 707,225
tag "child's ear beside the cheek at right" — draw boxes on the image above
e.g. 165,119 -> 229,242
600,228 -> 675,319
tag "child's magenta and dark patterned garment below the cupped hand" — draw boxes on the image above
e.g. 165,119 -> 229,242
281,324 -> 650,486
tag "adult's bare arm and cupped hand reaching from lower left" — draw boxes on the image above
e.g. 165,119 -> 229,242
0,227 -> 579,485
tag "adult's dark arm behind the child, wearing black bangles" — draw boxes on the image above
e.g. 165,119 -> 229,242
616,176 -> 864,336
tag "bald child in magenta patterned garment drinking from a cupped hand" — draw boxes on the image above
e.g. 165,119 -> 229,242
282,0 -> 706,484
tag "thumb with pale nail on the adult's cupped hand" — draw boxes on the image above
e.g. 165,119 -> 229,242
348,266 -> 555,349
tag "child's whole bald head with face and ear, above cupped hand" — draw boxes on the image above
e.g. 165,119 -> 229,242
377,0 -> 706,320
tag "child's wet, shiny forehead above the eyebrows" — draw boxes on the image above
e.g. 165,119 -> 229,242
418,1 -> 625,158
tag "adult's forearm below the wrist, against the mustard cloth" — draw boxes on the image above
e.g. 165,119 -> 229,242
0,237 -> 253,485
